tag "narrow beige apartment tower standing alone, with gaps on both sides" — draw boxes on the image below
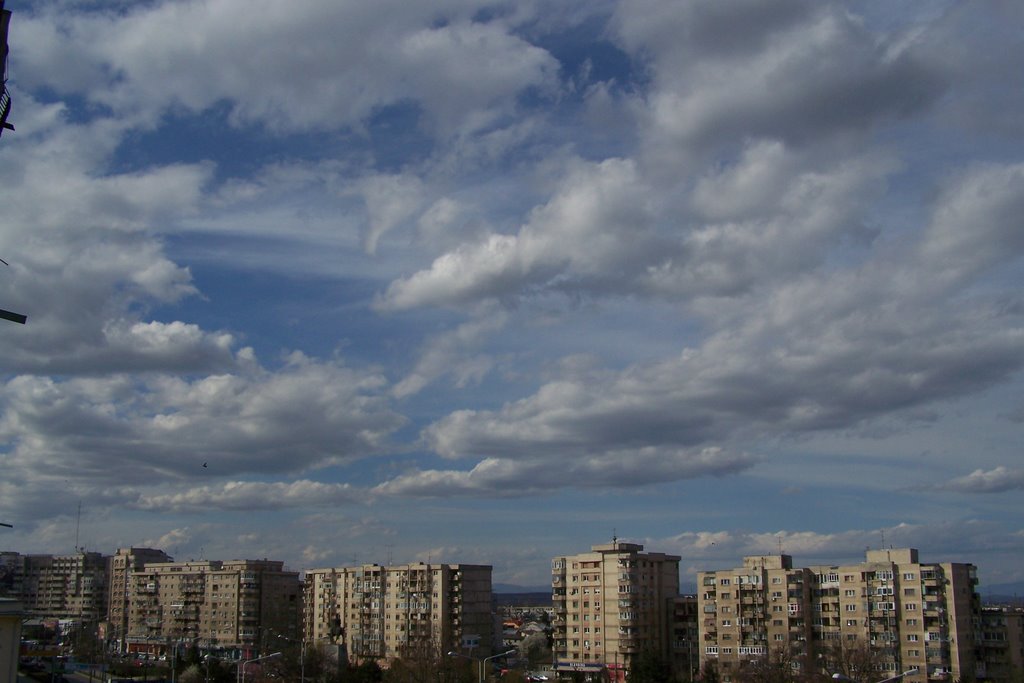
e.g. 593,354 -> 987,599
551,541 -> 680,679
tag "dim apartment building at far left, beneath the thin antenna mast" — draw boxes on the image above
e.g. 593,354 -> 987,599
7,551 -> 111,624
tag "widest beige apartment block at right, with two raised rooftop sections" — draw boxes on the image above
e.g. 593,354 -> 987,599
697,549 -> 980,683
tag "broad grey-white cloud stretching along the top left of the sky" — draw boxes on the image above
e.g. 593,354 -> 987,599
18,0 -> 557,132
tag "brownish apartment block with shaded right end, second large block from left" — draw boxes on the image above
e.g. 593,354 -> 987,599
125,560 -> 301,655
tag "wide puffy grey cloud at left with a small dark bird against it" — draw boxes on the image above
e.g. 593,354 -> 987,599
0,352 -> 403,497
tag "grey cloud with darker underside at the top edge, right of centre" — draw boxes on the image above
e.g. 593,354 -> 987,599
612,0 -> 944,156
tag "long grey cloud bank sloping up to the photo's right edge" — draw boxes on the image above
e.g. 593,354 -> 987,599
415,156 -> 1024,458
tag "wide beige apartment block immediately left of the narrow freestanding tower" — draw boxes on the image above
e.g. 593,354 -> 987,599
303,562 -> 494,663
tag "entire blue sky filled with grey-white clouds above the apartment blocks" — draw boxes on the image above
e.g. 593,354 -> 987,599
0,0 -> 1024,592
